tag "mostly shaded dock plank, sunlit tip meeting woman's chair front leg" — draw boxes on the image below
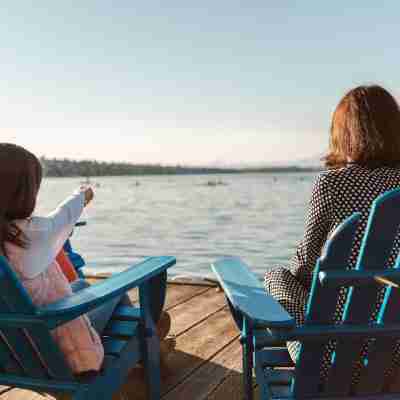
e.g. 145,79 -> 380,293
163,340 -> 242,400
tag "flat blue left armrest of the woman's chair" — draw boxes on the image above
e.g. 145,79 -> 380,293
211,257 -> 295,329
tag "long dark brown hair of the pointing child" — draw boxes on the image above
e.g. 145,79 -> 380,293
0,143 -> 42,254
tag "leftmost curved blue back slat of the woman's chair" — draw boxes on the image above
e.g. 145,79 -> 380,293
293,214 -> 360,398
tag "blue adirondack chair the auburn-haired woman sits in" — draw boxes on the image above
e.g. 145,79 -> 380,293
212,190 -> 400,400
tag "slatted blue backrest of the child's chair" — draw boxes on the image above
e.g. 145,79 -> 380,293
0,256 -> 73,380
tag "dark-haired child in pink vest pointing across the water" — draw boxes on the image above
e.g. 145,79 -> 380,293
0,143 -> 103,373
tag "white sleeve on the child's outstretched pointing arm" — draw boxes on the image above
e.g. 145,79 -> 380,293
19,191 -> 85,278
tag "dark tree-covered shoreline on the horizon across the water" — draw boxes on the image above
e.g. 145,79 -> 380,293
41,157 -> 318,177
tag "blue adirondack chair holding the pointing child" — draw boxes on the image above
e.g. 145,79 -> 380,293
0,256 -> 176,400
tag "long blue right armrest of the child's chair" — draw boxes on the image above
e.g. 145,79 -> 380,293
37,256 -> 176,329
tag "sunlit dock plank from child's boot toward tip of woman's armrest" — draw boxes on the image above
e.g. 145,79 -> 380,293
170,289 -> 226,336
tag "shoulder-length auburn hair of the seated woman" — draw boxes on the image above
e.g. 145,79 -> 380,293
324,85 -> 400,168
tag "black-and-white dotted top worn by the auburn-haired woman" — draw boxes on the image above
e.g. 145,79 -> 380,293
289,164 -> 400,290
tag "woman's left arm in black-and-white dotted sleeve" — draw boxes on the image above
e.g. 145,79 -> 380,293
289,173 -> 333,290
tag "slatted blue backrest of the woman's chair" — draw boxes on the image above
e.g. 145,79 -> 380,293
292,189 -> 400,398
